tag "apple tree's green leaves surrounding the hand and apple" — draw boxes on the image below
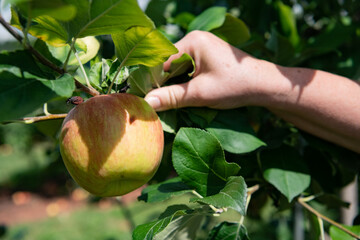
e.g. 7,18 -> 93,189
0,0 -> 360,239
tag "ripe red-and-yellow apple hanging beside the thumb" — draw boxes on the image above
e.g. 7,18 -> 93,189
60,93 -> 164,197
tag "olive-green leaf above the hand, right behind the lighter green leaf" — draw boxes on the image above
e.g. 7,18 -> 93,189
211,13 -> 250,46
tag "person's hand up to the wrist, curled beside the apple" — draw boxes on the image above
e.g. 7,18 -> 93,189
145,31 -> 260,111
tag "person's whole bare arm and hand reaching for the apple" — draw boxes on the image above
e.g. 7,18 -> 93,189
145,31 -> 360,153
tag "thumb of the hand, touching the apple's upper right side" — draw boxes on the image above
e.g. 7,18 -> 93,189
145,82 -> 196,111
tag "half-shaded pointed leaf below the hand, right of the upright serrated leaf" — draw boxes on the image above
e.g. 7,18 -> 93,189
206,110 -> 266,154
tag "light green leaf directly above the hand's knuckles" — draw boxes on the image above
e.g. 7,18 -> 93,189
188,7 -> 226,32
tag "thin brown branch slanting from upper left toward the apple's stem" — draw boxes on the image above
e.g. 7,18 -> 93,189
0,15 -> 100,96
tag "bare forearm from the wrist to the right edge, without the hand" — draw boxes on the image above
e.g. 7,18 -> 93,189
253,62 -> 360,152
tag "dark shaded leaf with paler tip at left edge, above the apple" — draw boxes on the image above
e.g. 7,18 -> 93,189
0,70 -> 75,121
